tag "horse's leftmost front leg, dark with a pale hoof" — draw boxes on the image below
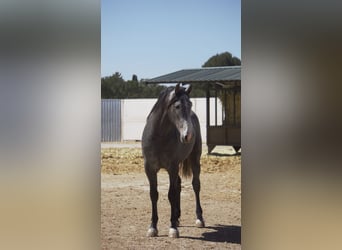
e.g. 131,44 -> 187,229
145,163 -> 158,237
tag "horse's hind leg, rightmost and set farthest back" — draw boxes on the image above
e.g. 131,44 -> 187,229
192,161 -> 205,227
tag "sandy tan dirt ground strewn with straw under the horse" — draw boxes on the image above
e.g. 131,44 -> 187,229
101,147 -> 241,249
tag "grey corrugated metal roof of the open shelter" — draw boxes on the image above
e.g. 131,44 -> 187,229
144,66 -> 241,84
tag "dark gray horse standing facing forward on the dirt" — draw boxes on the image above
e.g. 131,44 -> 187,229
142,84 -> 204,238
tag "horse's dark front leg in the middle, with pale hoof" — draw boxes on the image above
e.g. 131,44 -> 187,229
168,167 -> 181,238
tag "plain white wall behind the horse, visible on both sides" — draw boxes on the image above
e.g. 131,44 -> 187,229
121,98 -> 222,143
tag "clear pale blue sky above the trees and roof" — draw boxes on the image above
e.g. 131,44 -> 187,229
101,0 -> 241,80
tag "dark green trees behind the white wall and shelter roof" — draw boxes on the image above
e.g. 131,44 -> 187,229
101,52 -> 241,99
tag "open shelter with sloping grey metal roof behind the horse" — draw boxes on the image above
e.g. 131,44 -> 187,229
145,66 -> 241,153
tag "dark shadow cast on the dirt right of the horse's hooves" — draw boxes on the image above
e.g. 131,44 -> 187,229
181,225 -> 241,244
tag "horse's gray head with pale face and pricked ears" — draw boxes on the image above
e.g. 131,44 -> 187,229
168,83 -> 195,143
